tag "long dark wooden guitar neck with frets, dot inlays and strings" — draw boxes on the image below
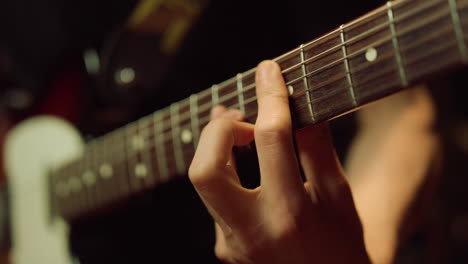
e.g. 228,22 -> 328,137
50,0 -> 468,219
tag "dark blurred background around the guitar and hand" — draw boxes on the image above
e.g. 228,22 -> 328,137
0,0 -> 468,264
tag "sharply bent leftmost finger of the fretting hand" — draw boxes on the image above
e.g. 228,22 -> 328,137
189,118 -> 253,228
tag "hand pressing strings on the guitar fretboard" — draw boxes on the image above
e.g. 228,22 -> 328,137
189,61 -> 370,264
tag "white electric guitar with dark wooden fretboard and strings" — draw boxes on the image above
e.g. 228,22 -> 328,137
4,0 -> 468,264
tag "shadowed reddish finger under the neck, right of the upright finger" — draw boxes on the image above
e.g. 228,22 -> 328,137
296,124 -> 355,212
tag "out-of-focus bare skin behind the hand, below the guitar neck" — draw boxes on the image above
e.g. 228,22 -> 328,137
346,87 -> 438,263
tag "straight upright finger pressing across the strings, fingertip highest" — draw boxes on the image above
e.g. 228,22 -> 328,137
255,61 -> 305,202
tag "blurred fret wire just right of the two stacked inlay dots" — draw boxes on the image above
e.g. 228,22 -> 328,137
153,111 -> 169,181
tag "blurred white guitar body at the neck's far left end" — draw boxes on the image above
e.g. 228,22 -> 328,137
4,116 -> 84,264
